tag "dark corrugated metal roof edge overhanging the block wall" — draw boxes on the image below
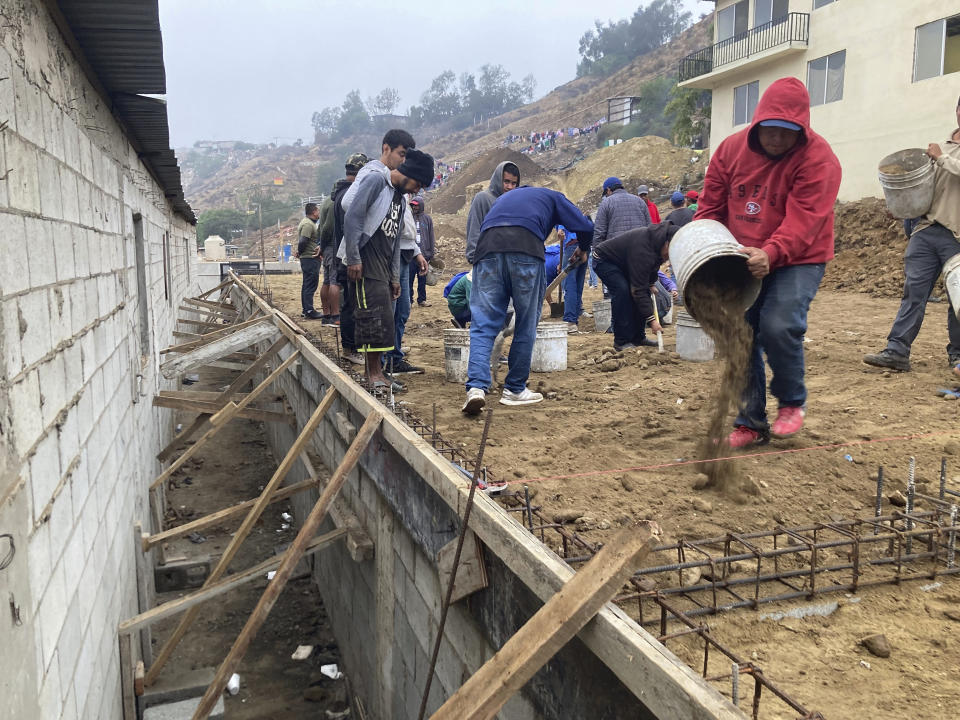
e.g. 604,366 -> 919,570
57,0 -> 197,223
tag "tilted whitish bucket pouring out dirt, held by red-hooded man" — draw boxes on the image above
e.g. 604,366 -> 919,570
670,220 -> 760,324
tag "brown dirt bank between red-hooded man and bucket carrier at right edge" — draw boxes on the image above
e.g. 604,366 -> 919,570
822,198 -> 916,297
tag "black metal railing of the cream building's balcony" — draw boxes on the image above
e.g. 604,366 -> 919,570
680,13 -> 810,82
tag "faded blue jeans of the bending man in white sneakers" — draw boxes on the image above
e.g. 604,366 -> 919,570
467,253 -> 547,393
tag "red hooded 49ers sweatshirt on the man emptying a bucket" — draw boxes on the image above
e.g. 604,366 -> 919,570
694,77 -> 840,270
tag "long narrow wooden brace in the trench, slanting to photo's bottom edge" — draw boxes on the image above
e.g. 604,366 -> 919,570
193,410 -> 383,720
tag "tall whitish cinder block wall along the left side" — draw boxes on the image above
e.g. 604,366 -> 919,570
0,0 -> 196,720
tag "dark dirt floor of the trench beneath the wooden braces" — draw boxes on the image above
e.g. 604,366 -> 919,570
153,370 -> 346,720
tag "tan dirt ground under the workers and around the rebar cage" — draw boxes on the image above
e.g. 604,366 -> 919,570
271,248 -> 960,720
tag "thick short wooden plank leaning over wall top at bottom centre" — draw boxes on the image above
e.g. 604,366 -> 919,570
431,522 -> 660,720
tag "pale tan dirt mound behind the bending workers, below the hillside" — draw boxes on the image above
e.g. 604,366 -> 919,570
560,135 -> 707,211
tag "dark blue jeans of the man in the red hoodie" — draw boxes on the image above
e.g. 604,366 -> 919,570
735,263 -> 826,432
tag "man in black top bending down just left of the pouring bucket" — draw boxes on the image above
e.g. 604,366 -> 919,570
593,222 -> 679,351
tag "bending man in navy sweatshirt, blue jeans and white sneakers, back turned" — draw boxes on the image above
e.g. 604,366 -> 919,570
462,187 -> 593,414
